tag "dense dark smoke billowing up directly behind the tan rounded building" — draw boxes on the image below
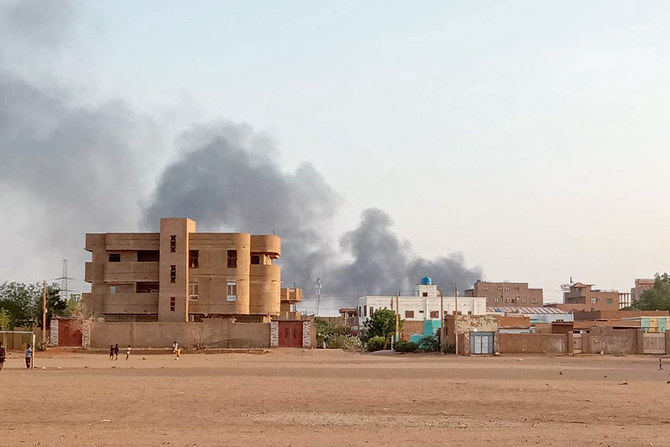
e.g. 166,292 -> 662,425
144,123 -> 481,296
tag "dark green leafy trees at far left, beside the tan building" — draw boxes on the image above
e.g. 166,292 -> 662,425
0,282 -> 66,329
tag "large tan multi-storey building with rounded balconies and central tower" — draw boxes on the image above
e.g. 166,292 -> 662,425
83,218 -> 284,322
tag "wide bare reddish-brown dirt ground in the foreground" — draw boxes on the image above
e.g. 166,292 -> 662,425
0,349 -> 670,446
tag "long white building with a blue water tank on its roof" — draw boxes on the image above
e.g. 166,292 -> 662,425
358,278 -> 486,326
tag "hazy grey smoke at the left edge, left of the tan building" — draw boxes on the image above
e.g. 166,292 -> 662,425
0,0 -> 158,279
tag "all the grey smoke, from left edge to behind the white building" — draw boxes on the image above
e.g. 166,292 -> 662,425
0,0 -> 481,304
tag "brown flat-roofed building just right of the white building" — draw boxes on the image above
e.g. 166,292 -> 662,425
465,281 -> 543,307
